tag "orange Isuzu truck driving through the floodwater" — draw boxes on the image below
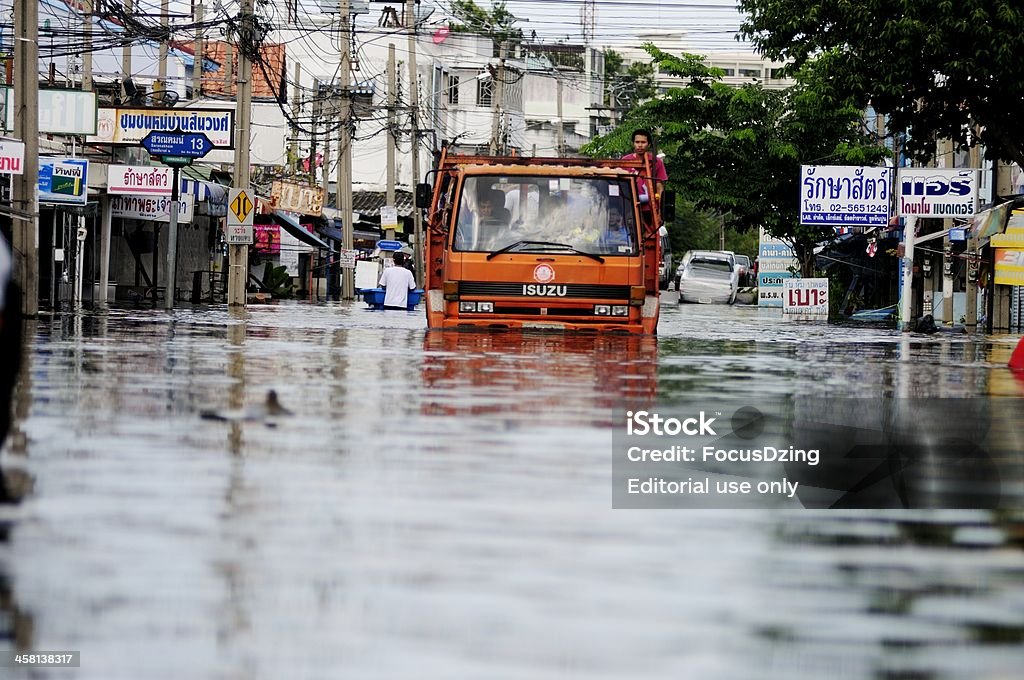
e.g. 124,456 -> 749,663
417,152 -> 672,335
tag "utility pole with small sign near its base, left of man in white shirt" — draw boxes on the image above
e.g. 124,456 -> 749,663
338,0 -> 355,300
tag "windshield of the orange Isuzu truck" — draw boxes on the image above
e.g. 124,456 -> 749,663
452,175 -> 638,256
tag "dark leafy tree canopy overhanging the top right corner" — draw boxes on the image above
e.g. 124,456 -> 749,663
739,0 -> 1024,166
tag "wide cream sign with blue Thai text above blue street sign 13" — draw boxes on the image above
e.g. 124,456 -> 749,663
88,109 -> 234,148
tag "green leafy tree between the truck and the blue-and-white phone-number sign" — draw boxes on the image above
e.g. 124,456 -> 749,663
583,44 -> 887,275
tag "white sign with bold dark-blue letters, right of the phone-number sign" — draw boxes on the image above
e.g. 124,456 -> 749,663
899,168 -> 978,217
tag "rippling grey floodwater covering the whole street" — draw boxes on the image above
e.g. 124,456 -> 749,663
0,301 -> 1024,680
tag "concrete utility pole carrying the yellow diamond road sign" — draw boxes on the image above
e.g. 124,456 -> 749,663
227,0 -> 255,305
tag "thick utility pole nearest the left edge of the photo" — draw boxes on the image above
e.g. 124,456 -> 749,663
11,0 -> 39,316
